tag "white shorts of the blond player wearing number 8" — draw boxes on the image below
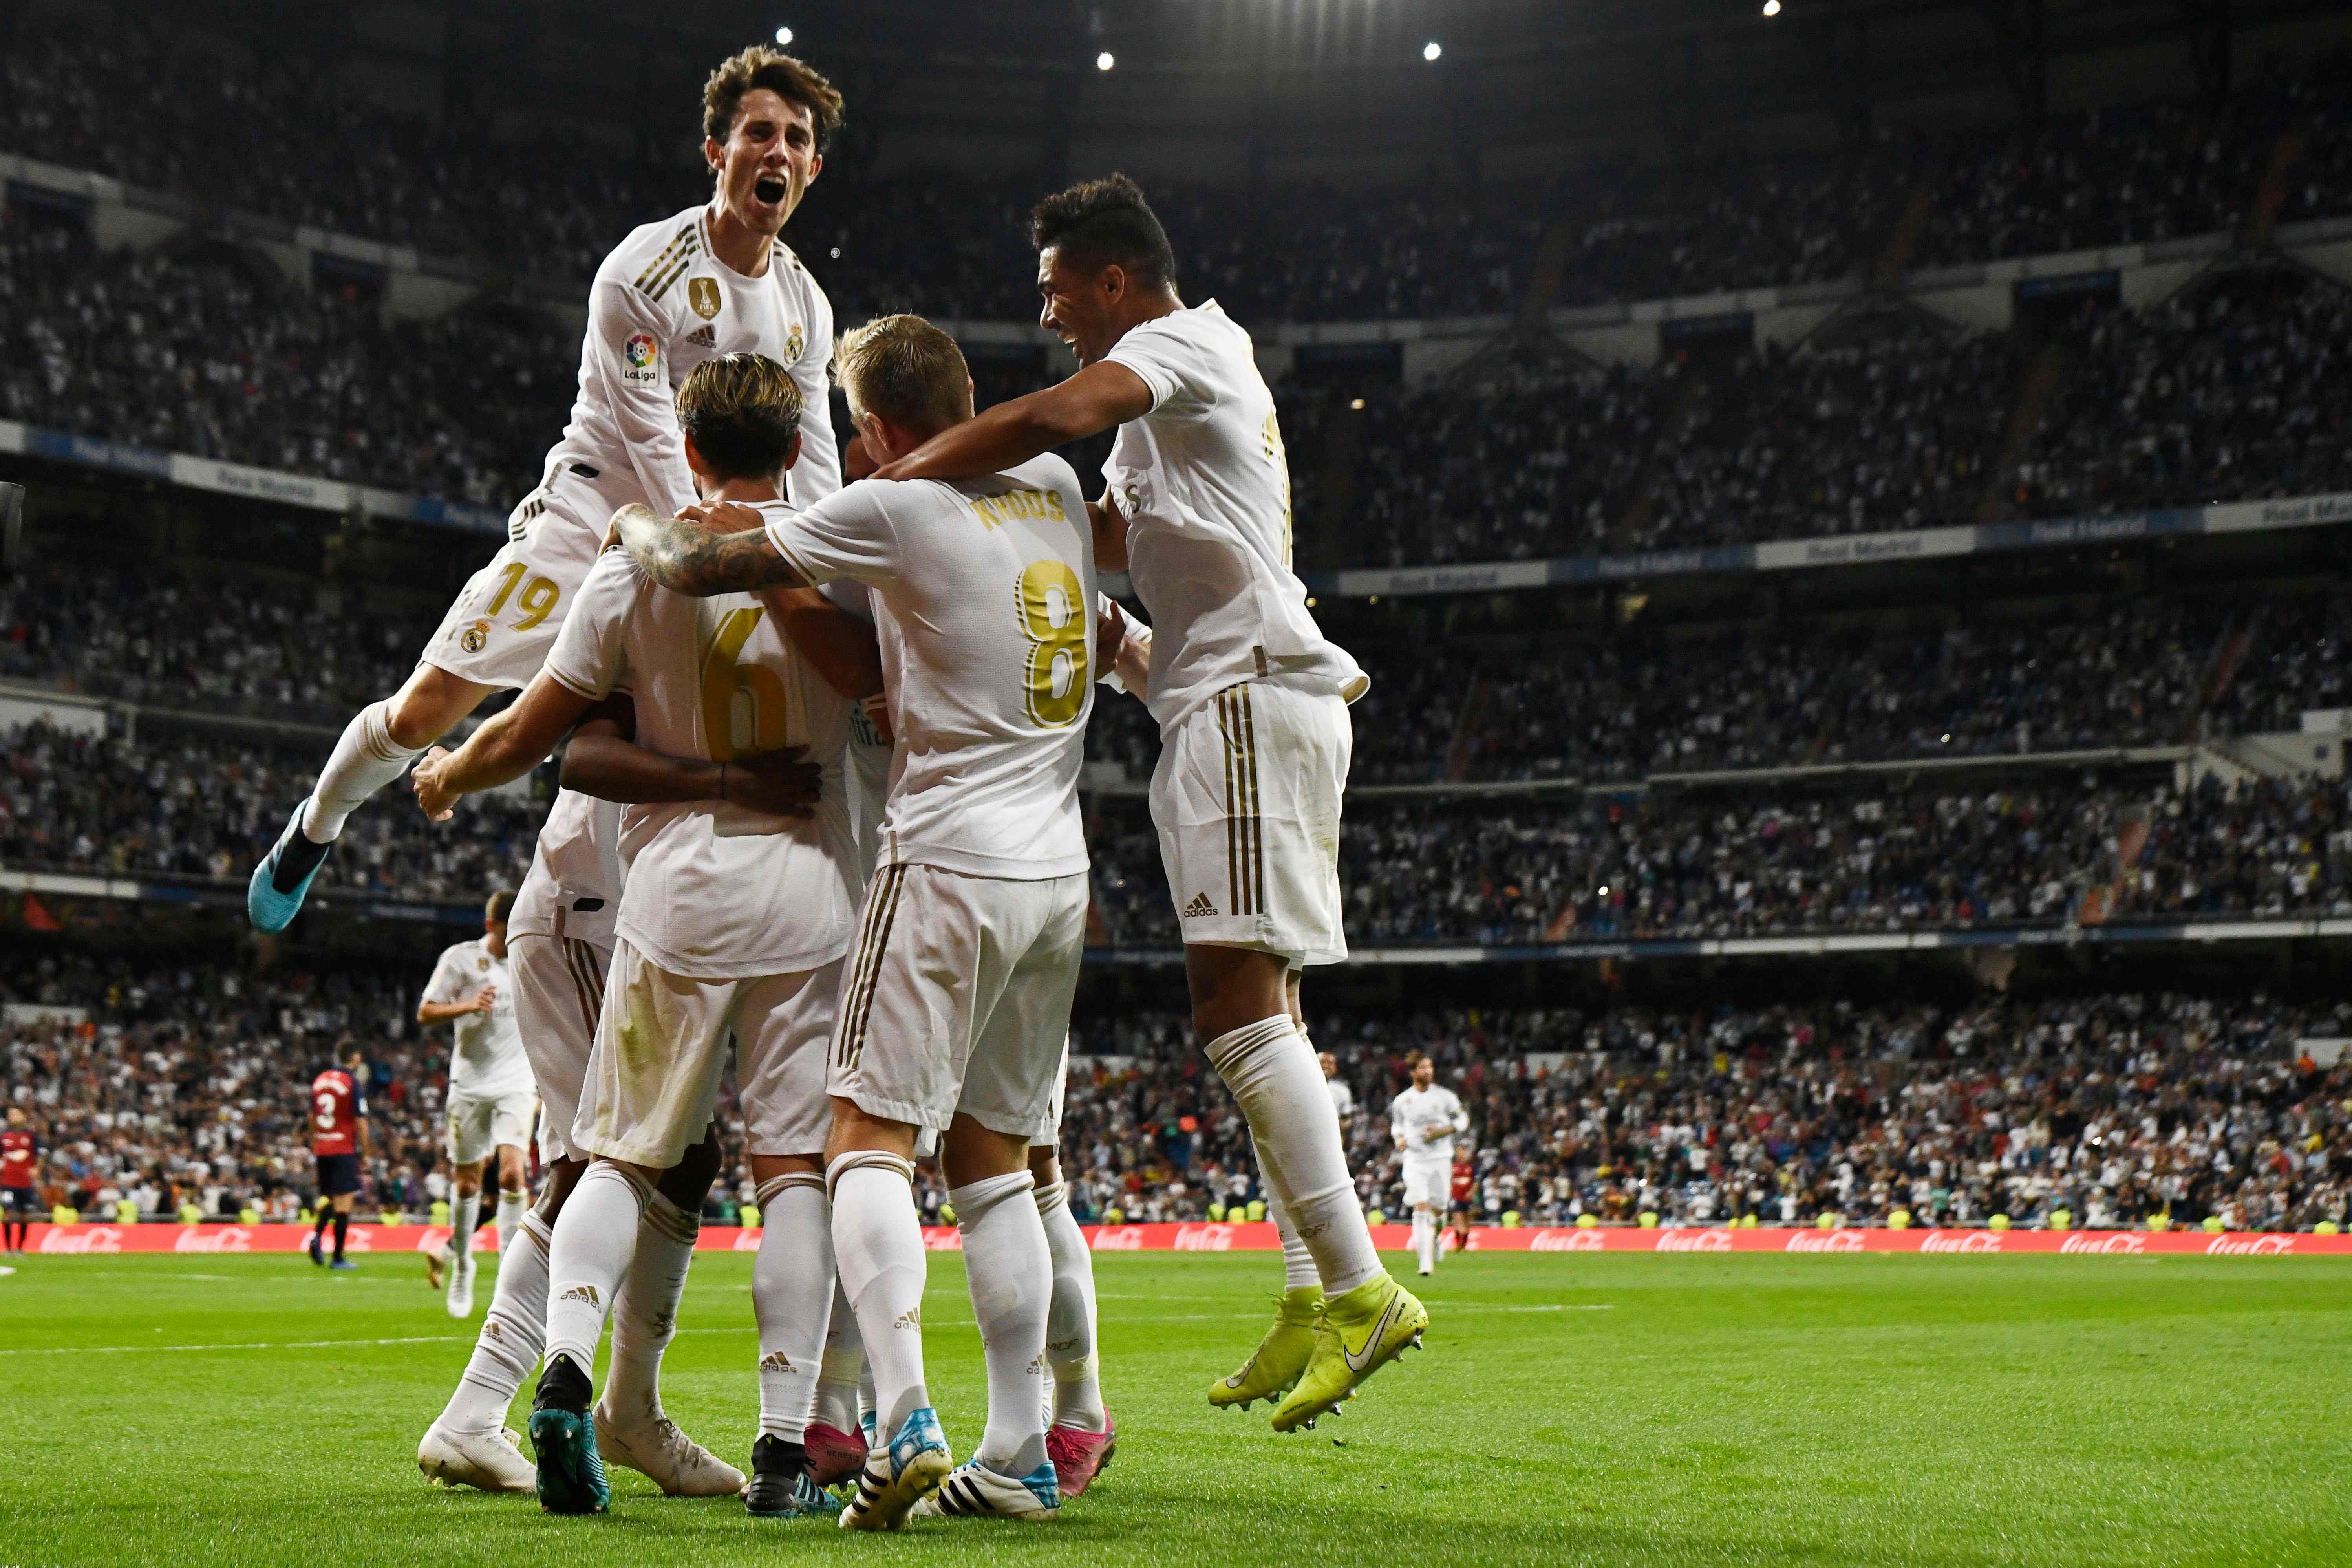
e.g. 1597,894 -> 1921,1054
825,863 -> 1086,1142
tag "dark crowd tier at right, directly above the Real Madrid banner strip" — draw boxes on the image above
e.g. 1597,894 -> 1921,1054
1284,275 -> 2352,567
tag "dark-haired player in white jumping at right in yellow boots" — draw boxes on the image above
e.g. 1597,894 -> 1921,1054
877,176 -> 1428,1432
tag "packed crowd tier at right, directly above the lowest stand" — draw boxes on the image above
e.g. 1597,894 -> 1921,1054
1091,776 -> 2352,948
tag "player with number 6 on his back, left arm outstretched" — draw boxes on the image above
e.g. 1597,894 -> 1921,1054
416,355 -> 863,1514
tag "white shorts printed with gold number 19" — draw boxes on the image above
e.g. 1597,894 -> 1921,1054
421,468 -> 611,686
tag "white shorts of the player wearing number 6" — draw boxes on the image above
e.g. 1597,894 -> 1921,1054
572,938 -> 842,1171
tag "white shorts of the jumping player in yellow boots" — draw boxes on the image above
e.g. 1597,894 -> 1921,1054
1152,682 -> 1355,968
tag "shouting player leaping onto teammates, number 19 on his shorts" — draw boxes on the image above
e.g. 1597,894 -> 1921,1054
245,47 -> 842,931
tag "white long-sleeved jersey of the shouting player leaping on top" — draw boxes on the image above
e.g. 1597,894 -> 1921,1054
548,207 -> 842,527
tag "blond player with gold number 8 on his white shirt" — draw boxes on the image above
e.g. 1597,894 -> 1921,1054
614,315 -> 1096,1530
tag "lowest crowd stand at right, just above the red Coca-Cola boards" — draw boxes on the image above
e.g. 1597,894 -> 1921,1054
1063,987 -> 2352,1230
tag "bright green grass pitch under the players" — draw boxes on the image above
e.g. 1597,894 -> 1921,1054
0,1253 -> 2352,1568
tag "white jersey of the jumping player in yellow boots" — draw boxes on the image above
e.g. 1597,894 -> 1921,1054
1103,298 -> 1371,734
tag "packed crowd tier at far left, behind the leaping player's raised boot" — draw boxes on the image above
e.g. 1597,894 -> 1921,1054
0,724 -> 546,905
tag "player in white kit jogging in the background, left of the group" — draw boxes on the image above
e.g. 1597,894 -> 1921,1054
416,889 -> 539,1316
